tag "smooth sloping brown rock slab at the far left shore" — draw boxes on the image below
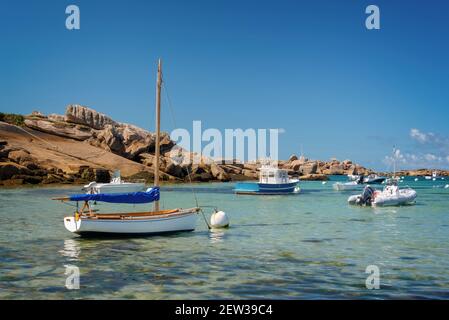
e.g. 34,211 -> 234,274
0,122 -> 145,186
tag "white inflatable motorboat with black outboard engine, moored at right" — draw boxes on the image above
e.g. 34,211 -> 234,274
348,180 -> 417,207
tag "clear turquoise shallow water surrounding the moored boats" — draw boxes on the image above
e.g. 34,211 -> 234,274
0,180 -> 449,299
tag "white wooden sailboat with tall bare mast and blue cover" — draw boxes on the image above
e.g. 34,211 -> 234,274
54,59 -> 200,235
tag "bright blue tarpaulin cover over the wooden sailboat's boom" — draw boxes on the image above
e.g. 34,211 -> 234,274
70,187 -> 159,203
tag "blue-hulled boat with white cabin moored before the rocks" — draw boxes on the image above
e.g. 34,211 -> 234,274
234,161 -> 300,195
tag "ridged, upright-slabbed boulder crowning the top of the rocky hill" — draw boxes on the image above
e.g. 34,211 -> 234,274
65,104 -> 117,130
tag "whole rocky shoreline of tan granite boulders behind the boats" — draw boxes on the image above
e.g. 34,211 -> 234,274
0,105 -> 371,185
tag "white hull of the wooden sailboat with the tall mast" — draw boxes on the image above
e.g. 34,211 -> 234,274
64,209 -> 198,235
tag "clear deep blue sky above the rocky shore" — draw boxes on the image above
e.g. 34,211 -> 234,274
0,0 -> 449,170
